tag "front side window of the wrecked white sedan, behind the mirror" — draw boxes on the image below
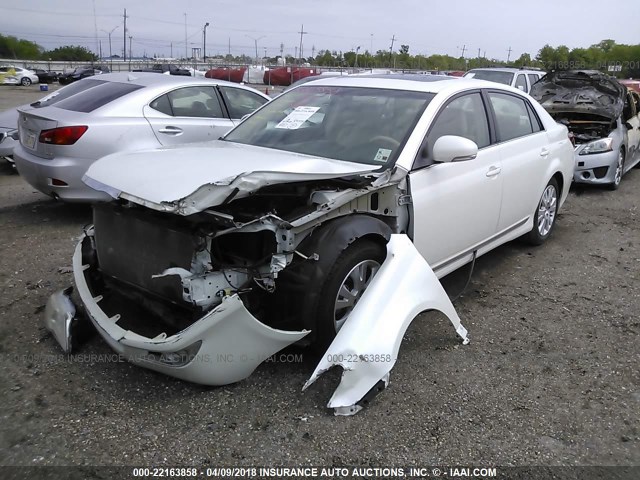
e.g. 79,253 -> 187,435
413,92 -> 491,169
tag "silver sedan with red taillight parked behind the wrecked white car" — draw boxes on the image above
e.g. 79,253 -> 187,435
13,73 -> 269,202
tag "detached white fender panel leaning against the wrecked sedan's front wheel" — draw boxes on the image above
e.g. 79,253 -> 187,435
303,234 -> 469,415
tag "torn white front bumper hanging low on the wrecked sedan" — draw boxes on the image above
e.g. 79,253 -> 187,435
61,230 -> 309,385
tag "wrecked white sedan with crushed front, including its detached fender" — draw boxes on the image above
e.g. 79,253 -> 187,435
47,76 -> 573,414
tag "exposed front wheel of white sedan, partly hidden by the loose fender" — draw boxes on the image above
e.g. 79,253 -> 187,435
315,239 -> 386,351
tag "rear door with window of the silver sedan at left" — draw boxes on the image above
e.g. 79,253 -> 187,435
143,85 -> 233,145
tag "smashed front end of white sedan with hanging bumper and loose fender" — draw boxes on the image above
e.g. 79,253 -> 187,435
47,164 -> 467,408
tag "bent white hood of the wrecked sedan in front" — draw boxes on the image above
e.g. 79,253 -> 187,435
83,140 -> 380,215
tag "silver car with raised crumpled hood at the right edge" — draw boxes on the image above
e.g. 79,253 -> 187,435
531,70 -> 640,190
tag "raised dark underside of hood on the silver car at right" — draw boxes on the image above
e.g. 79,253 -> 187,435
530,70 -> 626,119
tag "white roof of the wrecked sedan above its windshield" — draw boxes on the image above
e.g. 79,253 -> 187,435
292,74 -> 504,93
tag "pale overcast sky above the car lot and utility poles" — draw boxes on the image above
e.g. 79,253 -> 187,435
0,0 -> 640,60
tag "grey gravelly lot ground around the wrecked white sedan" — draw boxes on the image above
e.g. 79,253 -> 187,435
0,87 -> 640,466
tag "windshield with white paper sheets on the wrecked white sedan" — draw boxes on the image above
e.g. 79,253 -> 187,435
225,85 -> 434,166
